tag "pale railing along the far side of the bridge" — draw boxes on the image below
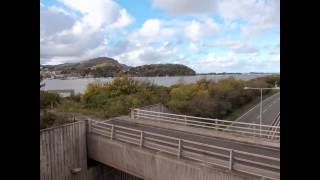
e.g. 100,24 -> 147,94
131,109 -> 280,139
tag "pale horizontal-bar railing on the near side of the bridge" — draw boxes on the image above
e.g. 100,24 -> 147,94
88,120 -> 280,180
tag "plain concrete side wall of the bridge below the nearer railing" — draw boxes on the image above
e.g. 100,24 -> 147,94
88,134 -> 259,180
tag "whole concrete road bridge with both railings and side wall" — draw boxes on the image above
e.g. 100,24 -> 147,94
40,105 -> 280,180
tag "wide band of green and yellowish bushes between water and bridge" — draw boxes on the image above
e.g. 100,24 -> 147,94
53,74 -> 280,122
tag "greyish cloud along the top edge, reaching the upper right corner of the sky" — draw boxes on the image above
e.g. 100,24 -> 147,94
153,0 -> 280,39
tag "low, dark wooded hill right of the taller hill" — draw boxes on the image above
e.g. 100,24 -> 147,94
126,64 -> 196,76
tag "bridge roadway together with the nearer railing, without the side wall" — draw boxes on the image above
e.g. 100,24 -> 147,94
90,118 -> 280,179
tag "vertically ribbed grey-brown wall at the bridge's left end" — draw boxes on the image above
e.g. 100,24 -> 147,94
40,121 -> 87,180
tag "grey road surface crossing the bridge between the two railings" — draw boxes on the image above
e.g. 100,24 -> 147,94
95,118 -> 280,175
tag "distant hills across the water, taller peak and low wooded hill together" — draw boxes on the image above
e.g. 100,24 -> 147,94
40,57 -> 195,77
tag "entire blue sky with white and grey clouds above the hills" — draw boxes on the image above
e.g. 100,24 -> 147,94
40,0 -> 280,73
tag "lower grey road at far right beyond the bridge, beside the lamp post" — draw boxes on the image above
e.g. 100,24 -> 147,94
230,92 -> 280,125
